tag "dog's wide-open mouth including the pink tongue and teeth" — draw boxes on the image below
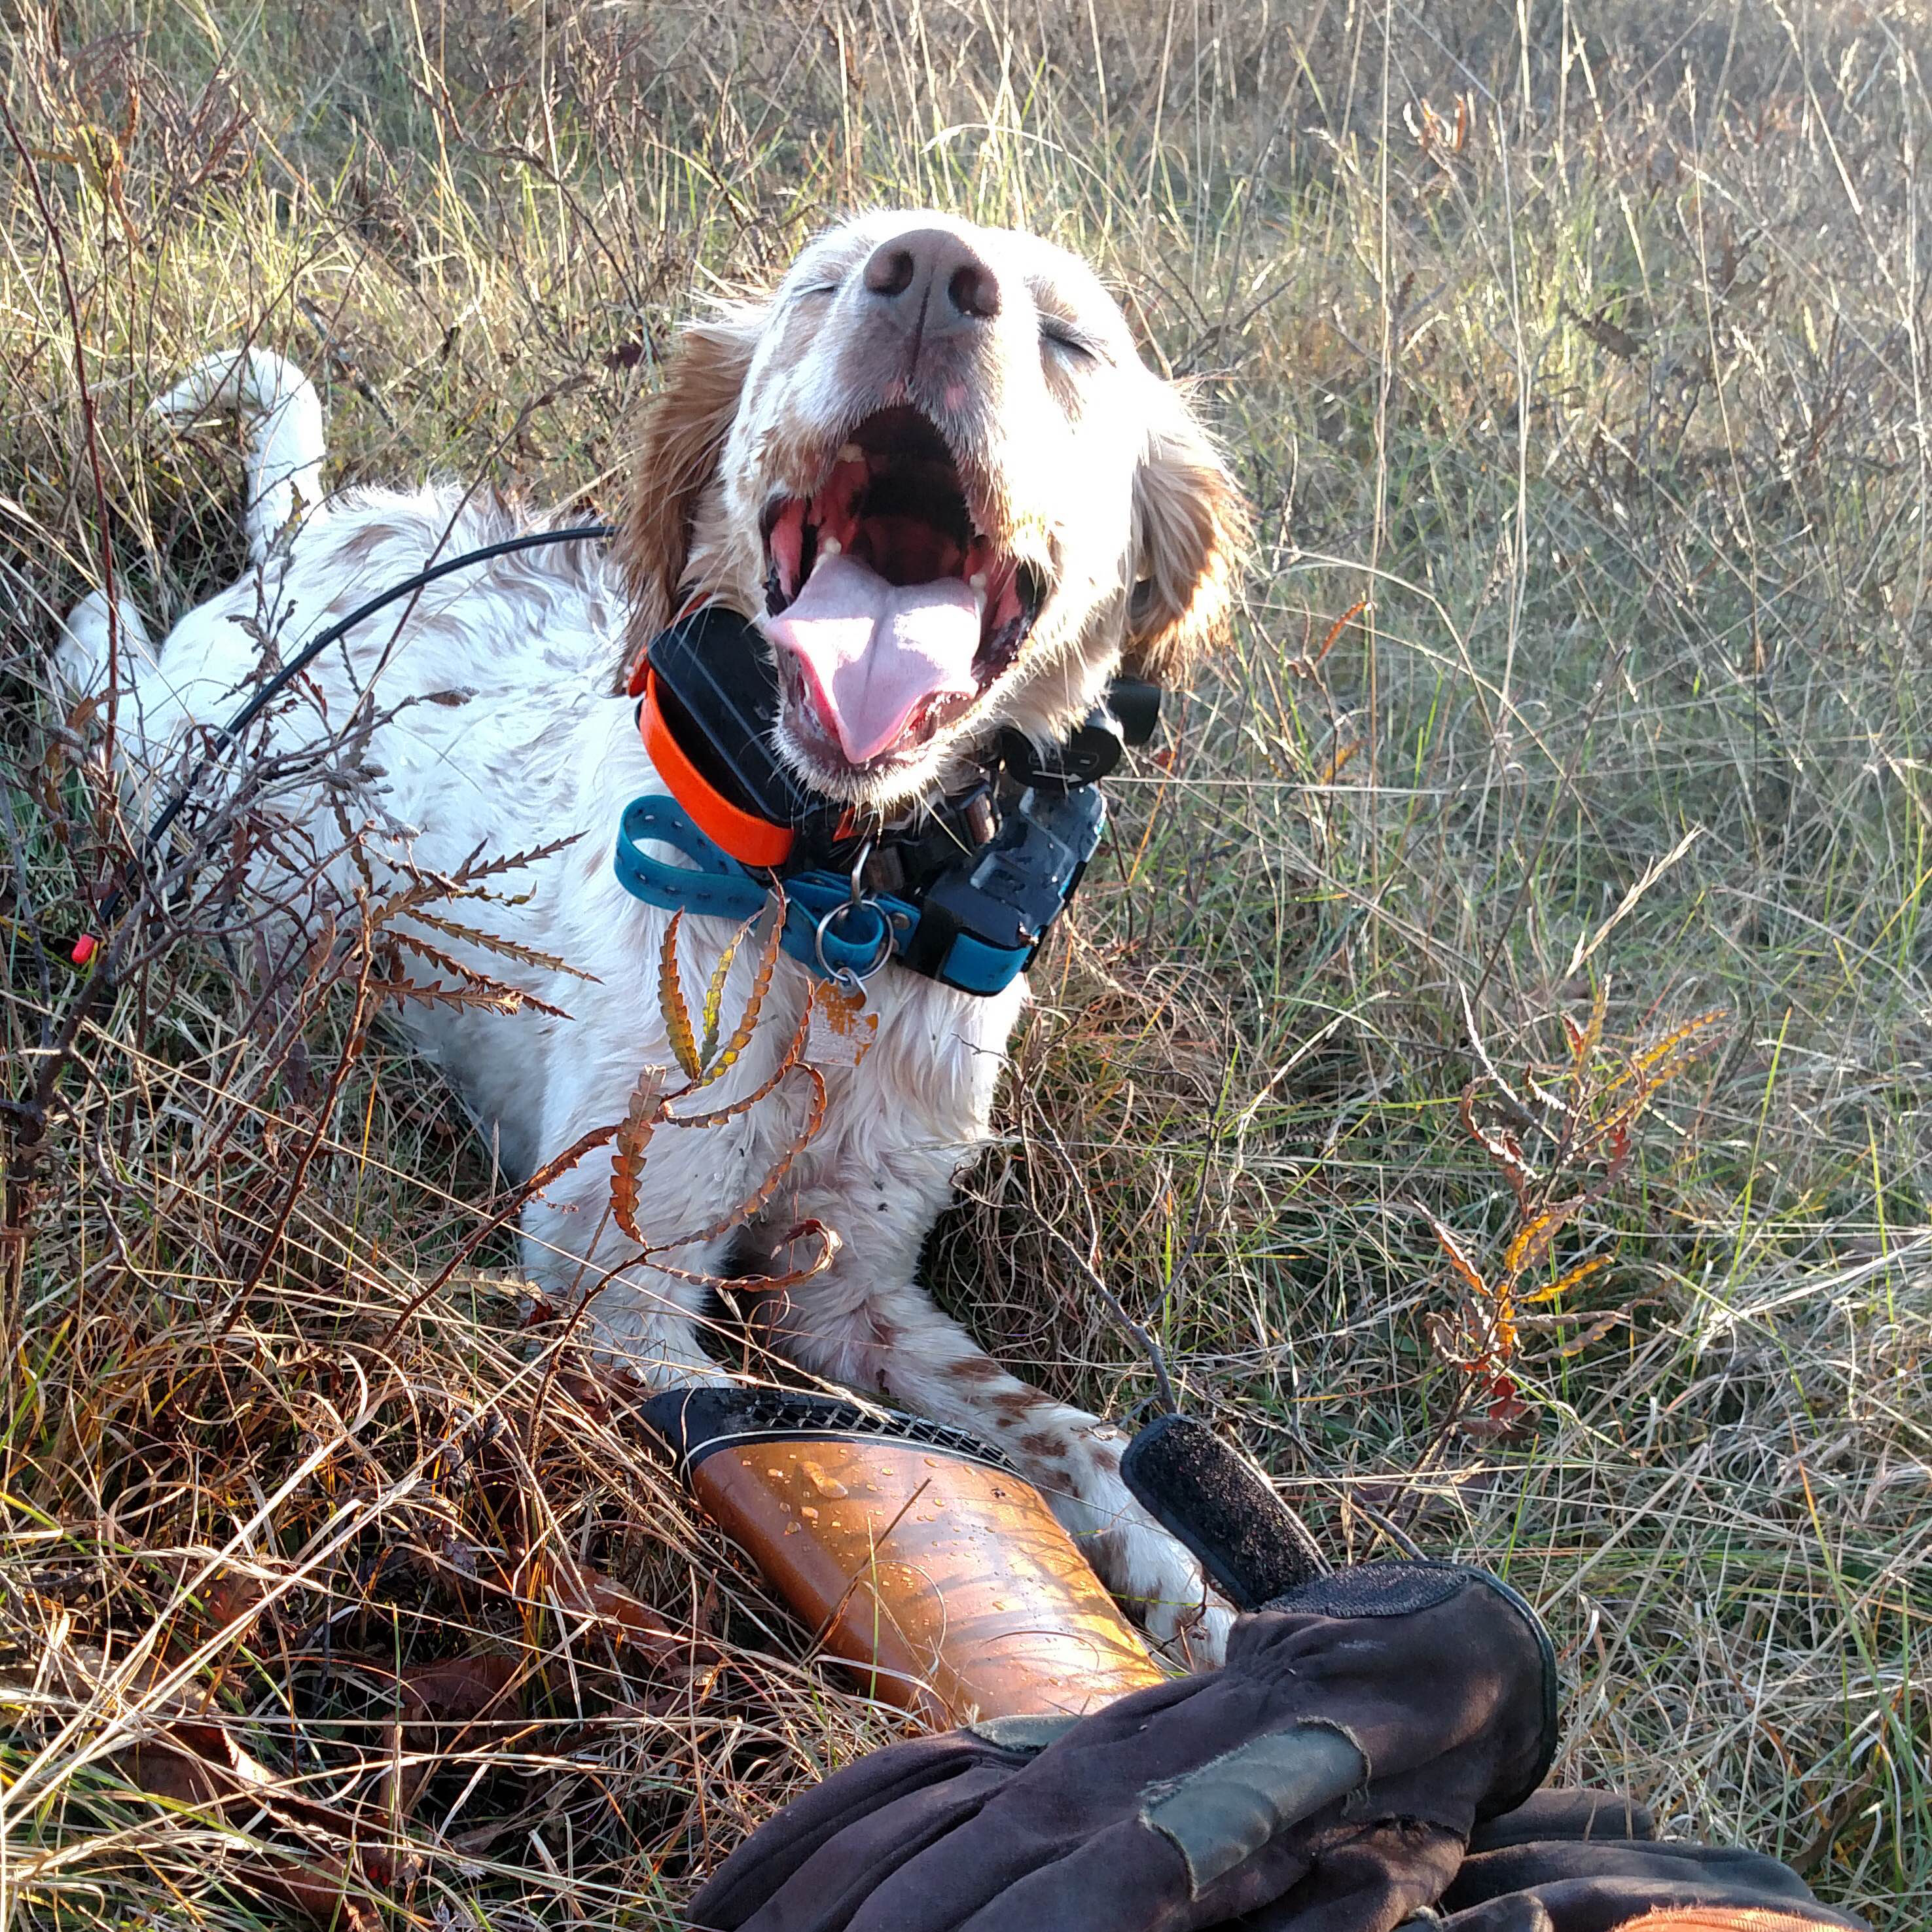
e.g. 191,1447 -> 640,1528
765,410 -> 1045,765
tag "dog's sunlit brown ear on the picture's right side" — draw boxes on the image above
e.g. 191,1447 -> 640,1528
1124,382 -> 1248,684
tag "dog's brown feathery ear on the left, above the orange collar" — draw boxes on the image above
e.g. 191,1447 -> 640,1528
617,307 -> 763,680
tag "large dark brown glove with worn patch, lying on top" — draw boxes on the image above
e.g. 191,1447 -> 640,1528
690,1563 -> 1555,1932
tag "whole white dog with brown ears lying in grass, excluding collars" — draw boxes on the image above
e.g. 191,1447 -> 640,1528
60,215 -> 1242,1660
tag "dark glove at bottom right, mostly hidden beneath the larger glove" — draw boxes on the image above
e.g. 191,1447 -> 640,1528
1416,1791 -> 1869,1932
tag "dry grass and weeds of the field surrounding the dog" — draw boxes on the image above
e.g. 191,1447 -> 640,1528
0,0 -> 1932,1928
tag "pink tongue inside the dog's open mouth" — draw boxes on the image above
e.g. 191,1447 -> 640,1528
765,556 -> 980,765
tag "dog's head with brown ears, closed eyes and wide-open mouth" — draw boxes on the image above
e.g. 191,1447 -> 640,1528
624,213 -> 1244,810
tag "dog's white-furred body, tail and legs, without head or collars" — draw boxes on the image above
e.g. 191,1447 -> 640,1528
58,238 -> 1228,1660
